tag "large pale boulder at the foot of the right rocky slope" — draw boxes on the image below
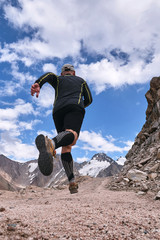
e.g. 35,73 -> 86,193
126,169 -> 147,182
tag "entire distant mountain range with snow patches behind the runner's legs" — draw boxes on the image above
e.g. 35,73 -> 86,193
0,153 -> 122,191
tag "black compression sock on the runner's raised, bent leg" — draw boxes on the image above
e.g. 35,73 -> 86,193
53,131 -> 74,149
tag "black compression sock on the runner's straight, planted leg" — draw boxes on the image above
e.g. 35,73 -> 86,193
61,152 -> 74,181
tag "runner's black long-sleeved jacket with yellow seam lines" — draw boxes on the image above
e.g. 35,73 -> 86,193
36,72 -> 92,113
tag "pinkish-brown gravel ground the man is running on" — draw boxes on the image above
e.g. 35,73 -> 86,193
0,179 -> 160,240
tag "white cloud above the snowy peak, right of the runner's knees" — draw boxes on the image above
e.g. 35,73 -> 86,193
79,131 -> 133,153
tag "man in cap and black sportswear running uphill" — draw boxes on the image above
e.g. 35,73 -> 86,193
31,64 -> 92,193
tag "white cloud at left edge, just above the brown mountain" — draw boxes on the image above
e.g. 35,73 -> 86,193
0,99 -> 45,161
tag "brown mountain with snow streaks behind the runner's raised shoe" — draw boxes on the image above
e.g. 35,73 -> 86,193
0,155 -> 65,190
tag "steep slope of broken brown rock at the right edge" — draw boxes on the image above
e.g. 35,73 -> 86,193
110,77 -> 160,199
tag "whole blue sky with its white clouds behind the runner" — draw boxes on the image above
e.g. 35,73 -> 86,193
0,0 -> 160,162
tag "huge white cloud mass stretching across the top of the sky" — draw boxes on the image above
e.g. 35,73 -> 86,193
0,0 -> 160,94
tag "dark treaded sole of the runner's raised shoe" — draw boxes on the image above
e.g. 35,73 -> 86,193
35,134 -> 53,176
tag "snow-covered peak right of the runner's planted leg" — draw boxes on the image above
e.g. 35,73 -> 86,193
79,153 -> 121,177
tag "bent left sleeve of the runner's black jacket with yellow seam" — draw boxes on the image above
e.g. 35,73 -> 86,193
35,72 -> 58,88
